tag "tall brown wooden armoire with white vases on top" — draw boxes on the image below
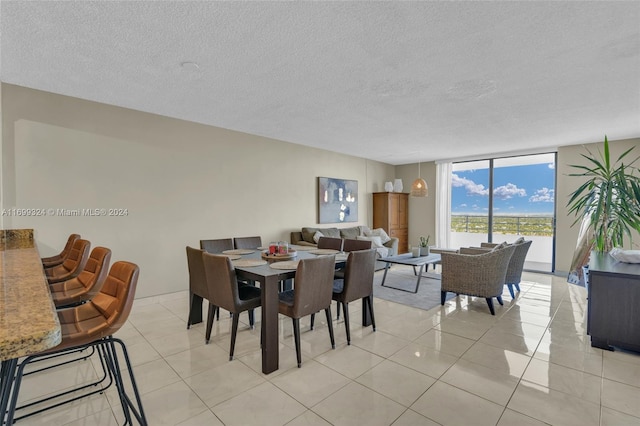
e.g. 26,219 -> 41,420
373,192 -> 409,254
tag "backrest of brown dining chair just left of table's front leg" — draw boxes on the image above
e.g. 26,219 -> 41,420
202,253 -> 240,312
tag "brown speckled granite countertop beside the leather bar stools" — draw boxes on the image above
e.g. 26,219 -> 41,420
0,230 -> 62,361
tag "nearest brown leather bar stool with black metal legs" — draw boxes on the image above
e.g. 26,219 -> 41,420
7,261 -> 147,425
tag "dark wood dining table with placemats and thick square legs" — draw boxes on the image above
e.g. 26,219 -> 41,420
192,245 -> 371,374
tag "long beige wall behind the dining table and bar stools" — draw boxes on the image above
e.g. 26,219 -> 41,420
0,84 -> 394,297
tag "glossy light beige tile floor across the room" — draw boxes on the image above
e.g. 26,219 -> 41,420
11,273 -> 640,426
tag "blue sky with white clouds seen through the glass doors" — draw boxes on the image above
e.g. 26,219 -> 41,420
451,155 -> 555,216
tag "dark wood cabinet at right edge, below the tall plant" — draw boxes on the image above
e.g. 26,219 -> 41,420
587,252 -> 640,352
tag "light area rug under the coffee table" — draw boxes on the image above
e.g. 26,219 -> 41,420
373,265 -> 455,310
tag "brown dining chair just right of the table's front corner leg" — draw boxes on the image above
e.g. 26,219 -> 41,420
278,256 -> 336,368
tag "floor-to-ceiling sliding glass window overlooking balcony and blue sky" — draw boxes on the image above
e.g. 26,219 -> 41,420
450,153 -> 556,272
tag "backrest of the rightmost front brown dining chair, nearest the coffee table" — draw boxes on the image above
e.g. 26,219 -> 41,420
342,249 -> 376,303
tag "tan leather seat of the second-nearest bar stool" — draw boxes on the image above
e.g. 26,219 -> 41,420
49,247 -> 111,309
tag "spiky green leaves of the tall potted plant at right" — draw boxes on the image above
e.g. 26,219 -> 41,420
567,135 -> 640,253
